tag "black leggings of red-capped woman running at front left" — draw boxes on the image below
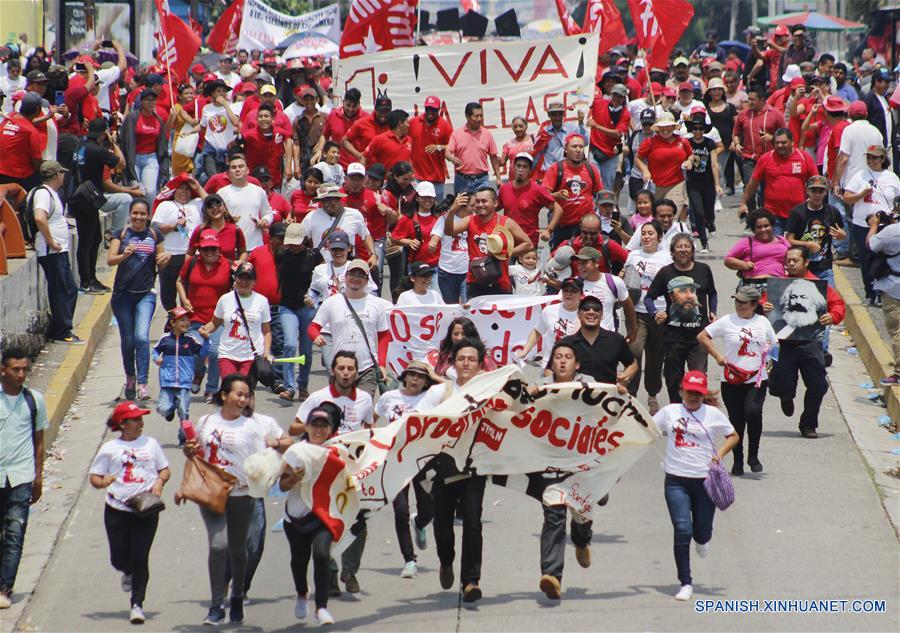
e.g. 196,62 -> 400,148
103,505 -> 159,606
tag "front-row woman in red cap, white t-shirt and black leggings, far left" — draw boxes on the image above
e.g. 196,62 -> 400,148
90,401 -> 169,624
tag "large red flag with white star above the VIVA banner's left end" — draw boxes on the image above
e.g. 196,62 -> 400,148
340,0 -> 419,59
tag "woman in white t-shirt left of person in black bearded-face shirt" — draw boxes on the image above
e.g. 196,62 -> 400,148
622,220 -> 672,404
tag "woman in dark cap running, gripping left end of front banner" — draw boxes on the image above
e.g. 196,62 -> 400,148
278,402 -> 341,625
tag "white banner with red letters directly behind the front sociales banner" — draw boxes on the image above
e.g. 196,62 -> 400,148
387,295 -> 559,375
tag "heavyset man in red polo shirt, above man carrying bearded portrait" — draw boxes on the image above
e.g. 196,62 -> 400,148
739,128 -> 819,235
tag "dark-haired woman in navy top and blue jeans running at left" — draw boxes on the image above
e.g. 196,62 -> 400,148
106,198 -> 171,400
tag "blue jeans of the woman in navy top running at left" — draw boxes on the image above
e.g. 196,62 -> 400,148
112,292 -> 156,385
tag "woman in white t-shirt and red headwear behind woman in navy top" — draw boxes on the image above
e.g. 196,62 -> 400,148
150,174 -> 207,310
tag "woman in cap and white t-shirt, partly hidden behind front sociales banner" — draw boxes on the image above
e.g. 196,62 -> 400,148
375,360 -> 443,578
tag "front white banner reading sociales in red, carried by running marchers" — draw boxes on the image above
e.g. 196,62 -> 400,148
332,366 -> 660,519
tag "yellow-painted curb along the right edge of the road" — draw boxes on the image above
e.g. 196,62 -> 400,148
834,266 -> 900,420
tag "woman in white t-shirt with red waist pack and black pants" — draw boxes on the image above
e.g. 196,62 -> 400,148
697,286 -> 778,476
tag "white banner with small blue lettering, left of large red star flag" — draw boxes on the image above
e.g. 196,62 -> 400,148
238,0 -> 341,50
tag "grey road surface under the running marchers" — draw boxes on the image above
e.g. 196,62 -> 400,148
18,198 -> 900,632
